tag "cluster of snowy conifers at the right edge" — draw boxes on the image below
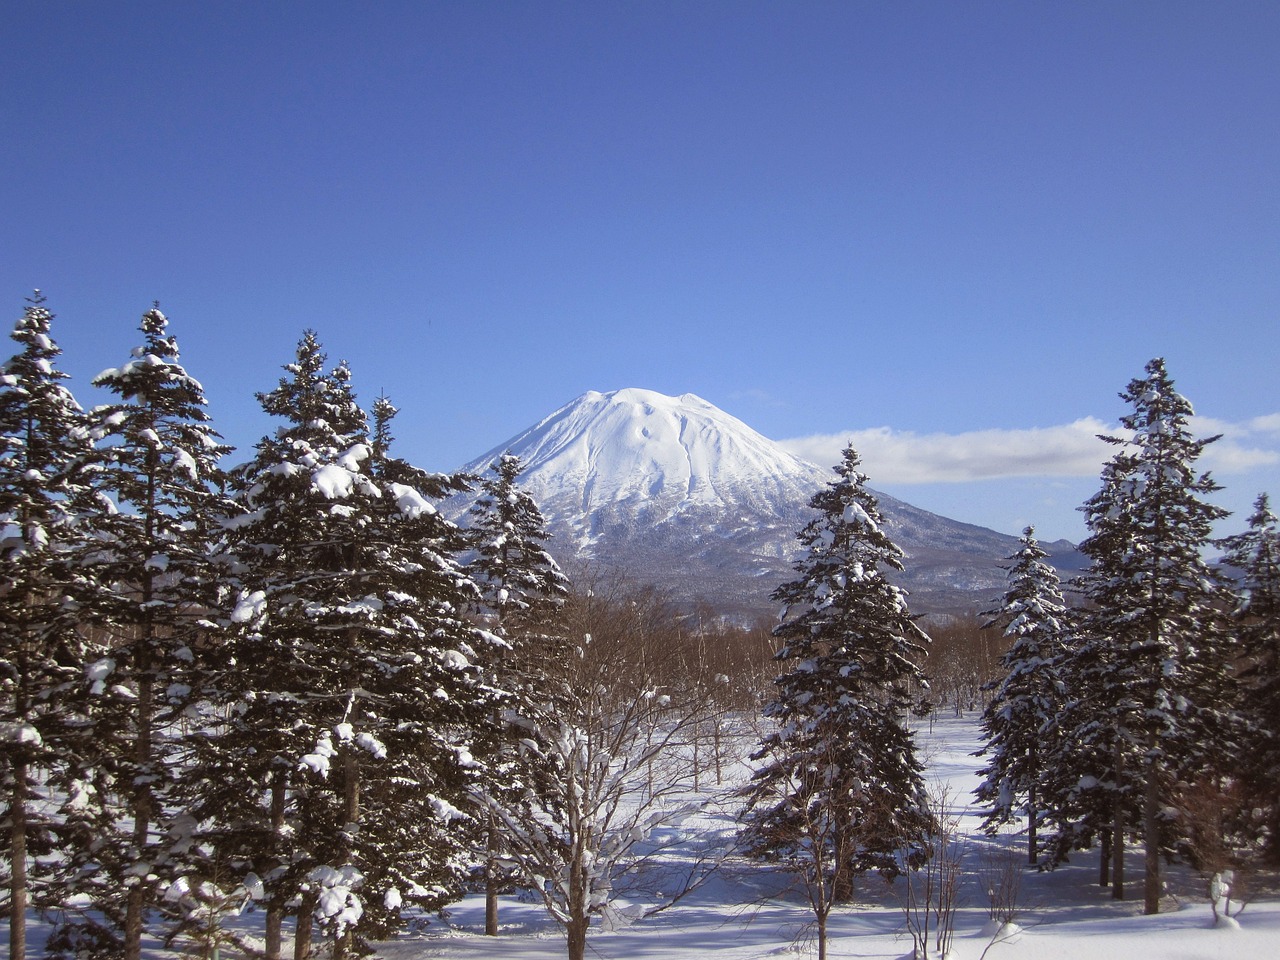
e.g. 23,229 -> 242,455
978,360 -> 1280,913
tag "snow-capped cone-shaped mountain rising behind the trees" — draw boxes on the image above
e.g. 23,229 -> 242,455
444,389 -> 1084,618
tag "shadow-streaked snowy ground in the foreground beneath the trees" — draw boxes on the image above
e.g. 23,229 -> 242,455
379,718 -> 1280,960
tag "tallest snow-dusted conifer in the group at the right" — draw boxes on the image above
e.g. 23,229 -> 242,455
1076,358 -> 1238,913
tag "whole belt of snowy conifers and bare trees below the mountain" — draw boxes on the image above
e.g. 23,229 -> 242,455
0,293 -> 1280,960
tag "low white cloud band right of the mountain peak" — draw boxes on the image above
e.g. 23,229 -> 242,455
778,413 -> 1280,484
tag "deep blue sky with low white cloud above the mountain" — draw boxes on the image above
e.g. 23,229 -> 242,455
0,0 -> 1280,540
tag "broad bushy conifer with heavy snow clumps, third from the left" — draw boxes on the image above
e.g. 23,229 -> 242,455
204,332 -> 492,956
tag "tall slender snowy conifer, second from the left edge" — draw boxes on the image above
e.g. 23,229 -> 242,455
70,307 -> 230,960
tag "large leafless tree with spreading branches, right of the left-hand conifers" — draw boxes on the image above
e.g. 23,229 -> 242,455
480,584 -> 732,960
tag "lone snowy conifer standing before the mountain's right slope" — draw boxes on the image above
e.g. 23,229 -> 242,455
744,447 -> 932,957
